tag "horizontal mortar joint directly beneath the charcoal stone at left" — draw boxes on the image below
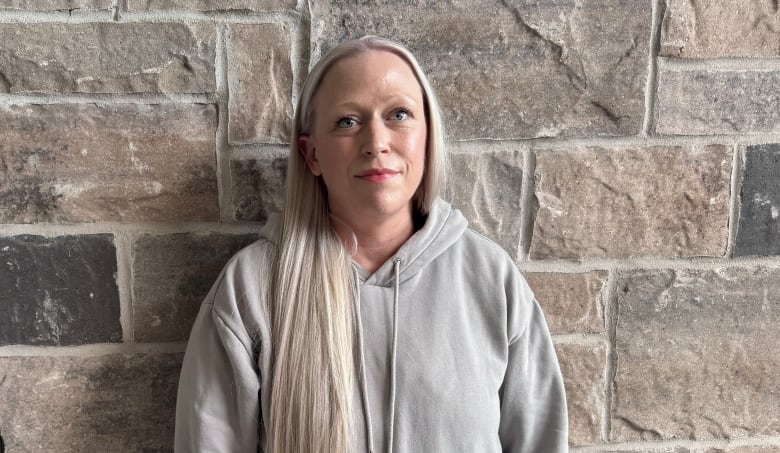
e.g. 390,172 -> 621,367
0,341 -> 187,357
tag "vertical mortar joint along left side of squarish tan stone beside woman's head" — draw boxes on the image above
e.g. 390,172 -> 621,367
214,24 -> 233,222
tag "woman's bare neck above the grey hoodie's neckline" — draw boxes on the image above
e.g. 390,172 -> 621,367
331,206 -> 414,273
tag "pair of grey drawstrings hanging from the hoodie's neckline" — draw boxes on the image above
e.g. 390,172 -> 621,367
355,258 -> 401,453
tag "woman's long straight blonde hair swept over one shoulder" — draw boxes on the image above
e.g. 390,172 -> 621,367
266,36 -> 447,453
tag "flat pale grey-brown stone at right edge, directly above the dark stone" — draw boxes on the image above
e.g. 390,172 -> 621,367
656,65 -> 780,135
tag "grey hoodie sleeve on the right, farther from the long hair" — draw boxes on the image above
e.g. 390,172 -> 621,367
499,276 -> 569,453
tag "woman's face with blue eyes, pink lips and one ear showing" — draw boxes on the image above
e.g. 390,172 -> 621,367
298,51 -> 427,224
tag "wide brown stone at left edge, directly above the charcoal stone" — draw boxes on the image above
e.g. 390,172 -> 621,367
0,104 -> 219,223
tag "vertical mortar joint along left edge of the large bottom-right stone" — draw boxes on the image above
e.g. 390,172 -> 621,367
601,270 -> 618,442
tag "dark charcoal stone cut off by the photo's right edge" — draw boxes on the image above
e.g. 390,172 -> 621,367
734,144 -> 780,256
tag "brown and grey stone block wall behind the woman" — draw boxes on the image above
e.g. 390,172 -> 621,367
0,0 -> 780,453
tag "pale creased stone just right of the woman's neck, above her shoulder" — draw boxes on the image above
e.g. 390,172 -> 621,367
447,152 -> 523,259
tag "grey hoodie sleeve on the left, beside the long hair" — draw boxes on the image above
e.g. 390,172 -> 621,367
174,270 -> 261,453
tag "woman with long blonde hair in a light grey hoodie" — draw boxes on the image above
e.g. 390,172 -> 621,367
176,37 -> 567,453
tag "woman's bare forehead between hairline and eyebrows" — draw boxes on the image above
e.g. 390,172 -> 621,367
315,50 -> 422,101
